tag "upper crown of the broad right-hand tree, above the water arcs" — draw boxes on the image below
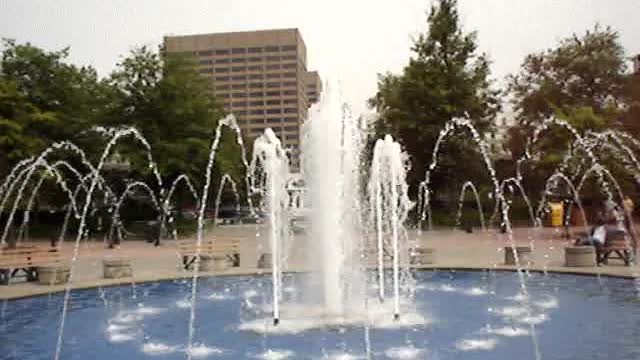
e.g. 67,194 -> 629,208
508,25 -> 627,151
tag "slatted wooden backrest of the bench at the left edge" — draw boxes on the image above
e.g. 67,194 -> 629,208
0,246 -> 63,269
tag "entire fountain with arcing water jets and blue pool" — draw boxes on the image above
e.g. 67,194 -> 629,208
0,85 -> 640,360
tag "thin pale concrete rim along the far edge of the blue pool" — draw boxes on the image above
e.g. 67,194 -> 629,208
0,264 -> 636,300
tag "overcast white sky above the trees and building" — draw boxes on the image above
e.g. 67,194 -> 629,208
0,0 -> 640,115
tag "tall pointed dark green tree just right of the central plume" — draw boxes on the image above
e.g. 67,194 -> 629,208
370,0 -> 500,202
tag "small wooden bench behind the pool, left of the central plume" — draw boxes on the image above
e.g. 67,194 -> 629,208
178,238 -> 240,270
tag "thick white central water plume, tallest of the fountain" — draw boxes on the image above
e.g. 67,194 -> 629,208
302,84 -> 364,315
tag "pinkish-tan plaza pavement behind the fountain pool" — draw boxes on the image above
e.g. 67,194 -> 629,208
0,225 -> 640,299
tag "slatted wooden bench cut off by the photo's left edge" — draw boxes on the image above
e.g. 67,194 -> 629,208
0,246 -> 63,285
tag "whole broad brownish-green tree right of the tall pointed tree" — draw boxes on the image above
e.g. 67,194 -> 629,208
507,25 -> 628,202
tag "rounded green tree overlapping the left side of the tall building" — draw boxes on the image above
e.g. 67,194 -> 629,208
105,47 -> 243,193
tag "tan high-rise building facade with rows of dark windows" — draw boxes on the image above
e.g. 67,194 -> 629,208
164,29 -> 321,169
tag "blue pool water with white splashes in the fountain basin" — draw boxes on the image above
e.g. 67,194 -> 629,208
0,271 -> 640,360
